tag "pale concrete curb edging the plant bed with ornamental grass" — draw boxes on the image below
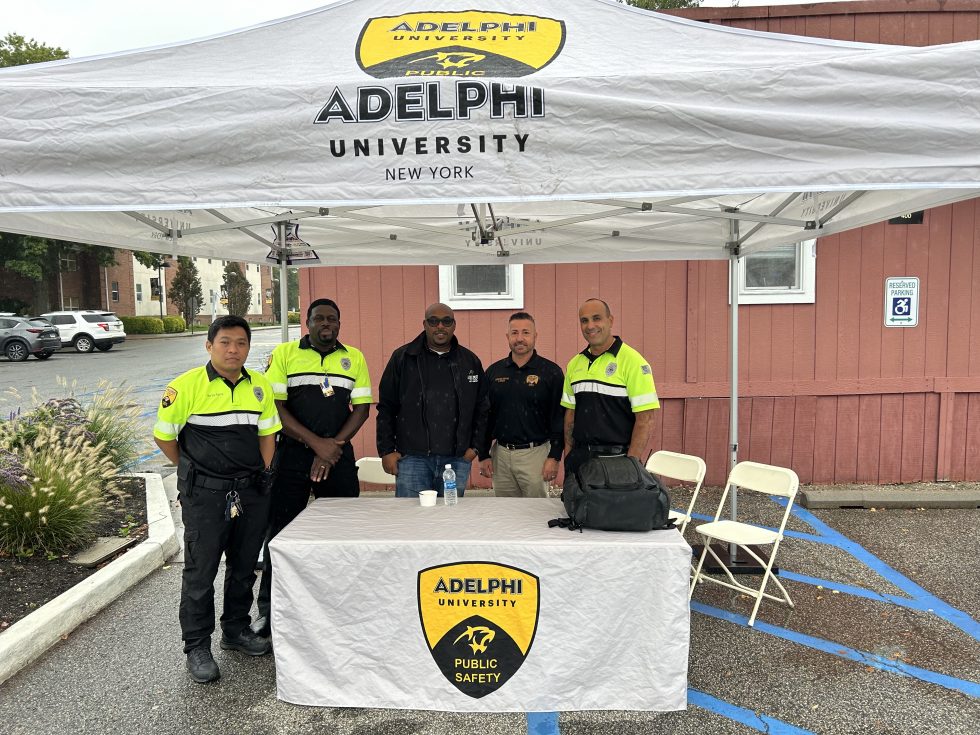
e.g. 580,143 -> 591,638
0,473 -> 180,684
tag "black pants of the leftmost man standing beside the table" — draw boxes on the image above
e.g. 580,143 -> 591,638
180,487 -> 270,653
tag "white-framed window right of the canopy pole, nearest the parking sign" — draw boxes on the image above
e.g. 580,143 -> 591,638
738,240 -> 817,304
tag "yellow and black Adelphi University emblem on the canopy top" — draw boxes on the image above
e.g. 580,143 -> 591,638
356,10 -> 565,79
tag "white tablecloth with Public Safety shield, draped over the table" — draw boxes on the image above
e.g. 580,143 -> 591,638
270,498 -> 691,712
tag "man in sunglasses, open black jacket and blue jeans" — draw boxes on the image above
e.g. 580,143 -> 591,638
377,304 -> 489,497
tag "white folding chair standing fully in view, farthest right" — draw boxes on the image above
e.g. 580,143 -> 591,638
688,462 -> 800,625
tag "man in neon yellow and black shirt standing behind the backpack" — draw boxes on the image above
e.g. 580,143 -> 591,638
561,299 -> 660,477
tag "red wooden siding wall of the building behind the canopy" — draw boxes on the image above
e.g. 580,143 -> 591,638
300,5 -> 980,484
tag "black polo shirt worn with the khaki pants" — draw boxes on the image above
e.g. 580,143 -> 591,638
480,351 -> 564,460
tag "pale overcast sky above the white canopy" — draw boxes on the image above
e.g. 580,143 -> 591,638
7,0 -> 860,58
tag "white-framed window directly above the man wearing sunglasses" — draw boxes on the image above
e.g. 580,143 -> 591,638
439,264 -> 524,309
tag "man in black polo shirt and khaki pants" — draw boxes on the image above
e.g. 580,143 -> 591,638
480,311 -> 564,498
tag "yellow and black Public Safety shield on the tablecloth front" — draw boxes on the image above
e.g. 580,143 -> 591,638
419,562 -> 540,699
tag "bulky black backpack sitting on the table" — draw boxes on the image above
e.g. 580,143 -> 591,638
554,455 -> 674,531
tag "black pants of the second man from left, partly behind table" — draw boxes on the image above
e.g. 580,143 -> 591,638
259,440 -> 361,618
